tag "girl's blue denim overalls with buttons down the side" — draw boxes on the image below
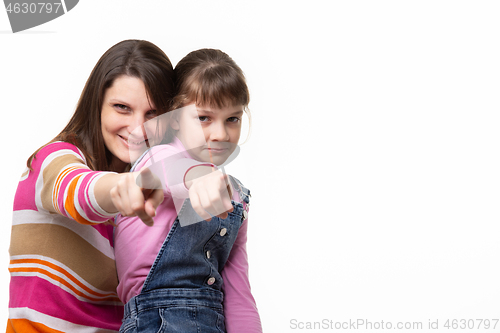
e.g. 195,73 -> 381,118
120,177 -> 250,333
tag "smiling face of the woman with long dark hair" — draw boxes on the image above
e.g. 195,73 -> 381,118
101,75 -> 157,171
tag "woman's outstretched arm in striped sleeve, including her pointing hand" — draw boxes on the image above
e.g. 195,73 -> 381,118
31,142 -> 163,224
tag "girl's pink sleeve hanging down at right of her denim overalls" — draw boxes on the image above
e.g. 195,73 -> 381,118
222,211 -> 262,333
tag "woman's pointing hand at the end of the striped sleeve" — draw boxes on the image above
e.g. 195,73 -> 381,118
110,169 -> 164,226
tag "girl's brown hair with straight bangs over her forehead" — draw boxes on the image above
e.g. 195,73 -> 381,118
174,49 -> 250,109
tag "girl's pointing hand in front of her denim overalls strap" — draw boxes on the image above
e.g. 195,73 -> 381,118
189,170 -> 233,221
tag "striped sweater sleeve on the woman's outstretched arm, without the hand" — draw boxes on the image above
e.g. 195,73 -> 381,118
30,142 -> 115,224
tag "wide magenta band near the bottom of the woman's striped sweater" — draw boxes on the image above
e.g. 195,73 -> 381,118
9,276 -> 123,331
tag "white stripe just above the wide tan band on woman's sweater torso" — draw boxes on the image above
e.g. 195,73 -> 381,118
12,209 -> 115,260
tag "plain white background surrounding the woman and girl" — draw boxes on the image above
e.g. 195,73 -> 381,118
0,0 -> 500,332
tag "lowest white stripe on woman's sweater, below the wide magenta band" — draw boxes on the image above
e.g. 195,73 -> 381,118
9,308 -> 117,333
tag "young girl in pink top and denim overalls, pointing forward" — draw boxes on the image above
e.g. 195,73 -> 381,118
115,49 -> 262,333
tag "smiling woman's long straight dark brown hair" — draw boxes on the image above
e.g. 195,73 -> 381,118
27,40 -> 175,171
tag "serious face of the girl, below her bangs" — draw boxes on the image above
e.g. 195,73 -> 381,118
170,103 -> 243,165
